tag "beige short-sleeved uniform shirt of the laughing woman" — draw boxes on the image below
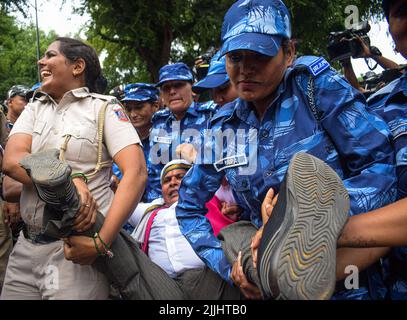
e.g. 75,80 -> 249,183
10,88 -> 141,228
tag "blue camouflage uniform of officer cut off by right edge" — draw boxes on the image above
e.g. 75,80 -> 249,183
368,73 -> 407,300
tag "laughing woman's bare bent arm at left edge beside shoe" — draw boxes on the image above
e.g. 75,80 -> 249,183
3,133 -> 32,185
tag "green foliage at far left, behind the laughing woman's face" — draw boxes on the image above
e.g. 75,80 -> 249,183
0,11 -> 56,101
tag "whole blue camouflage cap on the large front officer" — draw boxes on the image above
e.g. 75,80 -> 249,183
221,0 -> 291,57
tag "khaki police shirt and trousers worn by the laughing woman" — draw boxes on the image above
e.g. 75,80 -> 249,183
2,88 -> 141,299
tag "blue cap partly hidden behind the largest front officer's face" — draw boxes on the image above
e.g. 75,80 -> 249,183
192,51 -> 229,92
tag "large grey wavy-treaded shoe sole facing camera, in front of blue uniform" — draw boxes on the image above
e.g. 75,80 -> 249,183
258,153 -> 349,300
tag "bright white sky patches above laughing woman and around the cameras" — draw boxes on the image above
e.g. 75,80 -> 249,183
12,0 -> 406,76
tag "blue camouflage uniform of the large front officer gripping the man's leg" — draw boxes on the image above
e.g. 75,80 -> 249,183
176,57 -> 396,295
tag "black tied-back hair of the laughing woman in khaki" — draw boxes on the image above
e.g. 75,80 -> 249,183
55,37 -> 107,93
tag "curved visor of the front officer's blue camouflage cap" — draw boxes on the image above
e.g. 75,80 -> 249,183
220,33 -> 283,57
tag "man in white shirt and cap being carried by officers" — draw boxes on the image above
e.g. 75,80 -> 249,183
129,159 -> 240,299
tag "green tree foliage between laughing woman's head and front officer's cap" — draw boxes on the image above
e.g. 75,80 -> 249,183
80,0 -> 234,86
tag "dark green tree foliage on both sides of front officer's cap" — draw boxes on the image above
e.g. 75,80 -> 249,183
78,0 -> 381,86
